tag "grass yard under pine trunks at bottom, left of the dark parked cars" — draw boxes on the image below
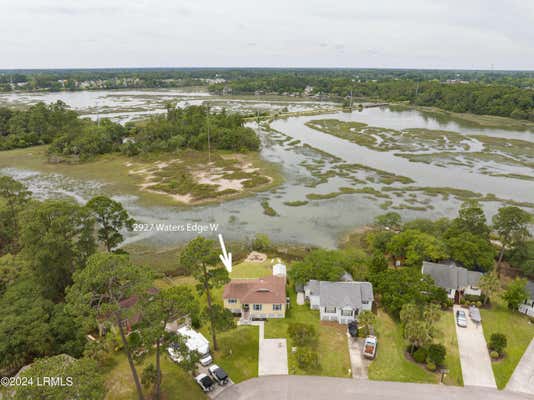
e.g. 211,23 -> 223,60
105,352 -> 206,400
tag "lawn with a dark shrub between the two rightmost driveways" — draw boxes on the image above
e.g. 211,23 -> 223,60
481,297 -> 534,389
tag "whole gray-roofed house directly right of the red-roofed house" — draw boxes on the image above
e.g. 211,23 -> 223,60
304,280 -> 374,324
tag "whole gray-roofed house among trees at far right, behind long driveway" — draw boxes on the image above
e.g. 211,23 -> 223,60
421,261 -> 483,303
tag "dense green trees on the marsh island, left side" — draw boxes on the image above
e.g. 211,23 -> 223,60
0,101 -> 260,161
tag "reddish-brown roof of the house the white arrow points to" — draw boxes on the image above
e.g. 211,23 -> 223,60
223,276 -> 286,304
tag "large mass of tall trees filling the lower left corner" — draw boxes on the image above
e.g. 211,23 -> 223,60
0,176 -> 234,400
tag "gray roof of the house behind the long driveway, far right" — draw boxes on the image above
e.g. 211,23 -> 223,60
421,261 -> 483,290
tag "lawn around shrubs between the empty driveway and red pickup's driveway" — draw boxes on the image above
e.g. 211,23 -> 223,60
265,290 -> 350,377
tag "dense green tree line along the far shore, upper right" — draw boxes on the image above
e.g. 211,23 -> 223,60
210,74 -> 534,121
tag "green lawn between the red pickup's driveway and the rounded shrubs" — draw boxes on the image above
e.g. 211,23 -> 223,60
369,310 -> 440,383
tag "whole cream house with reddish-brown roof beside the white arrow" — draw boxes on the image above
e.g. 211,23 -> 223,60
223,276 -> 287,321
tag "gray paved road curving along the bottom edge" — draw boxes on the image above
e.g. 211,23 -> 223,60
217,375 -> 534,400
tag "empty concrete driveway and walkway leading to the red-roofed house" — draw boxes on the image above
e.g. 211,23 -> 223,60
252,321 -> 288,376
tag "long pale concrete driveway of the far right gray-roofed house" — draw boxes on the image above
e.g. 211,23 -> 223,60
453,306 -> 497,388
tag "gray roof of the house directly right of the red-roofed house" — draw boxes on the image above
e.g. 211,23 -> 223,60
319,281 -> 374,309
